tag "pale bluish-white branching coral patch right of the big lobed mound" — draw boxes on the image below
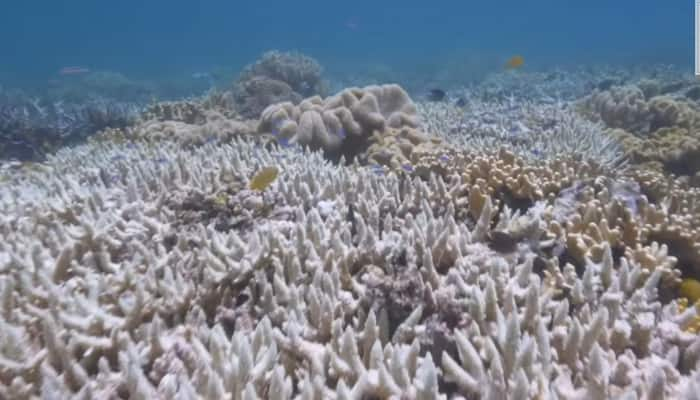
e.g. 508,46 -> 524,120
417,97 -> 624,167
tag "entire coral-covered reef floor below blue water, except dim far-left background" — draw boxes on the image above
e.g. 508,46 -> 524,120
0,53 -> 700,400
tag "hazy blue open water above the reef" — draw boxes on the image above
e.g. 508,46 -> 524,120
0,0 -> 693,85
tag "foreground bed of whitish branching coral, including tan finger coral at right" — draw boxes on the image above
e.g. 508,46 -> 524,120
0,133 -> 700,399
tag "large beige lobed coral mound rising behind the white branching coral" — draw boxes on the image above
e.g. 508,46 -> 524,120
258,85 -> 429,168
